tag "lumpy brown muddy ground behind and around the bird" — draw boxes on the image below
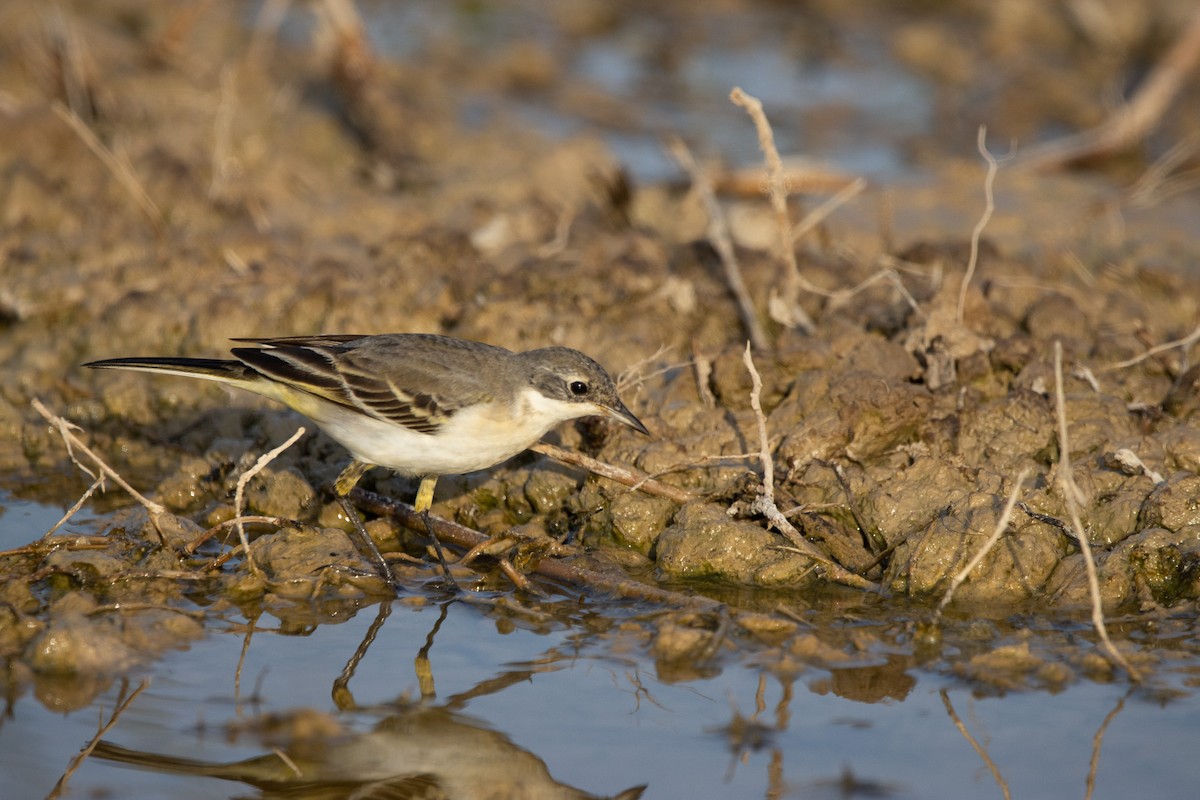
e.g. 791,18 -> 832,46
0,1 -> 1200,705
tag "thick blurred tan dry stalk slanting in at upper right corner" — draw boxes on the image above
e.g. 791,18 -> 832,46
1020,10 -> 1200,169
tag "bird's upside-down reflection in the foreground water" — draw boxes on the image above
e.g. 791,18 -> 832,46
92,601 -> 646,800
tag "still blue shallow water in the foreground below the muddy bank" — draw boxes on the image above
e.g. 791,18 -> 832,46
0,585 -> 1200,799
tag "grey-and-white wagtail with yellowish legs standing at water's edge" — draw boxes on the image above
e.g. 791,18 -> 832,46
84,333 -> 649,588
